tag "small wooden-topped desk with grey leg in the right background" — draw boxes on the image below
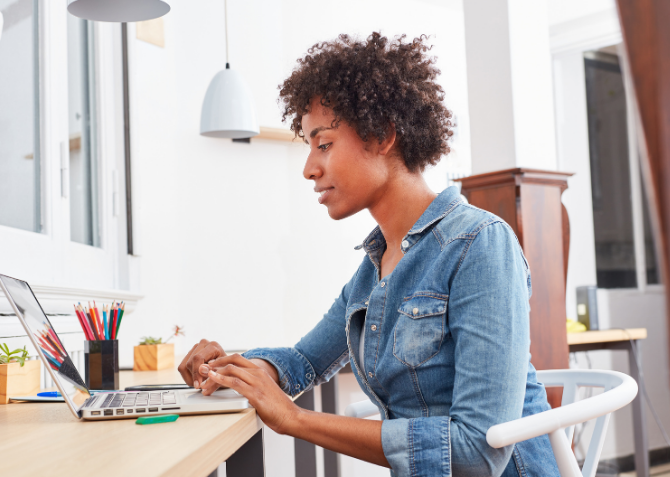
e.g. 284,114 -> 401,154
568,328 -> 649,477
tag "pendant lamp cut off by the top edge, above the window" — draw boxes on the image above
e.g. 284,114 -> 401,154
67,0 -> 170,22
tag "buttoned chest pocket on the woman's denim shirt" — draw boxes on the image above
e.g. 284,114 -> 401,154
393,292 -> 449,368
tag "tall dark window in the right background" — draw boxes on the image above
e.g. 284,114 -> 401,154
584,47 -> 659,288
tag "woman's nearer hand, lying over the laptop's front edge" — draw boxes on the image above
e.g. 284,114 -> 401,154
200,354 -> 300,434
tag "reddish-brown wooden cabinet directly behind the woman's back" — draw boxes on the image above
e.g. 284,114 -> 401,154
460,168 -> 572,407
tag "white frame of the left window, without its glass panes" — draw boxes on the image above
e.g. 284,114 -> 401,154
0,0 -> 130,302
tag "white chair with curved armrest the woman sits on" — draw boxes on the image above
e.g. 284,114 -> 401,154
345,369 -> 637,477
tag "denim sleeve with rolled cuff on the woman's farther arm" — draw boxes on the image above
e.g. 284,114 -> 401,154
242,268 -> 356,396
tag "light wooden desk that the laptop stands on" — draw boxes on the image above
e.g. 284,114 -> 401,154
0,369 -> 264,477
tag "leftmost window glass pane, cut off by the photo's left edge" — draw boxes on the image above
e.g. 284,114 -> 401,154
0,0 -> 42,232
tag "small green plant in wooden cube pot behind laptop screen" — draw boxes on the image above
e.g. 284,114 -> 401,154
0,343 -> 40,404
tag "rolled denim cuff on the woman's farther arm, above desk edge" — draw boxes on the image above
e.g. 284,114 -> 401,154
242,348 -> 315,396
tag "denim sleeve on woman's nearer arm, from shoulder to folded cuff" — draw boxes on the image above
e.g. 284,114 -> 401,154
382,222 -> 530,477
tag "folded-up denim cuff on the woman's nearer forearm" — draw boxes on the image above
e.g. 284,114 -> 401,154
382,416 -> 451,477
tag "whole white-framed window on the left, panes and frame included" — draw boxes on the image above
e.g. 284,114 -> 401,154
0,0 -> 130,292
